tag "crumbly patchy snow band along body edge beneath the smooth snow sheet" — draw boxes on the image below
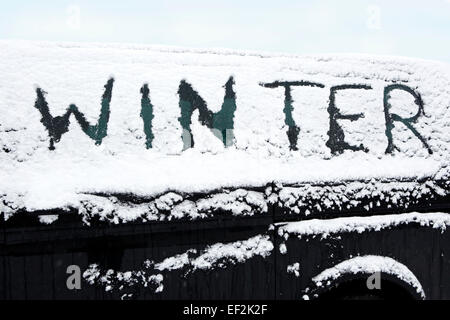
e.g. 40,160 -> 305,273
0,180 -> 442,225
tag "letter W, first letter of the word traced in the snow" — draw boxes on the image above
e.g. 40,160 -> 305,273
34,78 -> 114,150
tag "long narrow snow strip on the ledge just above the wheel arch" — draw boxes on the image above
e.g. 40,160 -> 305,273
278,212 -> 450,238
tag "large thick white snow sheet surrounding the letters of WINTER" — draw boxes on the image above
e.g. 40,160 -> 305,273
0,41 -> 450,215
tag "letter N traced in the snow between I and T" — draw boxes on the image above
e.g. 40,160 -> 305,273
178,77 -> 236,150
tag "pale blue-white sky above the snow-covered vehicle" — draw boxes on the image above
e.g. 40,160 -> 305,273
0,0 -> 450,62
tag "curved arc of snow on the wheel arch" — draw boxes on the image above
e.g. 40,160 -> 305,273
312,255 -> 425,299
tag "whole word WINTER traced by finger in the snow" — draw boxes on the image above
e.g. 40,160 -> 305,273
35,77 -> 433,154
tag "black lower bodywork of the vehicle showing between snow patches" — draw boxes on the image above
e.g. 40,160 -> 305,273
0,182 -> 450,299
